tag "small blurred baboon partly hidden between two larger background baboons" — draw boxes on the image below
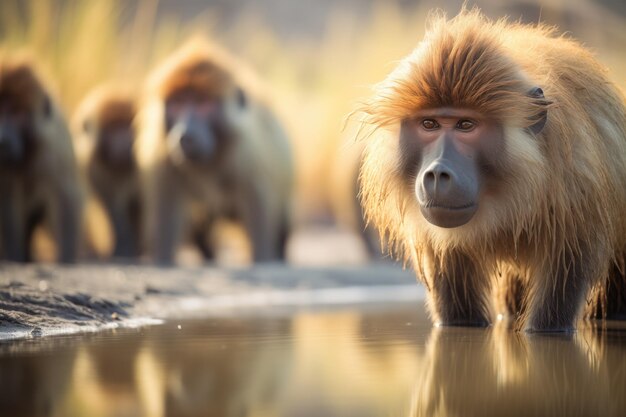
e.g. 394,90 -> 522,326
73,85 -> 141,257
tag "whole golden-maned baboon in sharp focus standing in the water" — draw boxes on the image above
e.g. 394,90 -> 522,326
361,10 -> 626,331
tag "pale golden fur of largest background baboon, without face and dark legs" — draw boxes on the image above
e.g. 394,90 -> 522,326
136,39 -> 293,262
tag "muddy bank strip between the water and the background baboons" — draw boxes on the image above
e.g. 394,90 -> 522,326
0,263 -> 422,340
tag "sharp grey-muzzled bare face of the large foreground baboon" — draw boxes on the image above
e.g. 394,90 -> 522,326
400,108 -> 504,227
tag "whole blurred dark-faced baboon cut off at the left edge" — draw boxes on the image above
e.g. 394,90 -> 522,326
0,53 -> 81,262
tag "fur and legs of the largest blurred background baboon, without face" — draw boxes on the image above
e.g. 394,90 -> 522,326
136,38 -> 293,263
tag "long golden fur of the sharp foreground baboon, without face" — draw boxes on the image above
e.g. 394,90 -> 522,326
361,10 -> 626,328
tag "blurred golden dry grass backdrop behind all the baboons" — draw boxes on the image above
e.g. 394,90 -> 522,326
0,0 -> 626,224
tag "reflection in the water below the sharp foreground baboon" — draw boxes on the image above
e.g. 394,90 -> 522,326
409,323 -> 626,417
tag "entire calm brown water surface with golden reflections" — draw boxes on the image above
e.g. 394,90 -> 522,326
0,304 -> 626,417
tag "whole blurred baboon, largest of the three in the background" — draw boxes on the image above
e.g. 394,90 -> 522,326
137,39 -> 292,263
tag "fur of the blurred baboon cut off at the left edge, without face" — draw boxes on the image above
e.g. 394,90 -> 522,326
0,51 -> 82,262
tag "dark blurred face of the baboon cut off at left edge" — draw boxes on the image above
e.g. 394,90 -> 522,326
0,89 -> 44,167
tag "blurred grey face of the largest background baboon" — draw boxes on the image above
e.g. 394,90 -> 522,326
165,88 -> 243,164
